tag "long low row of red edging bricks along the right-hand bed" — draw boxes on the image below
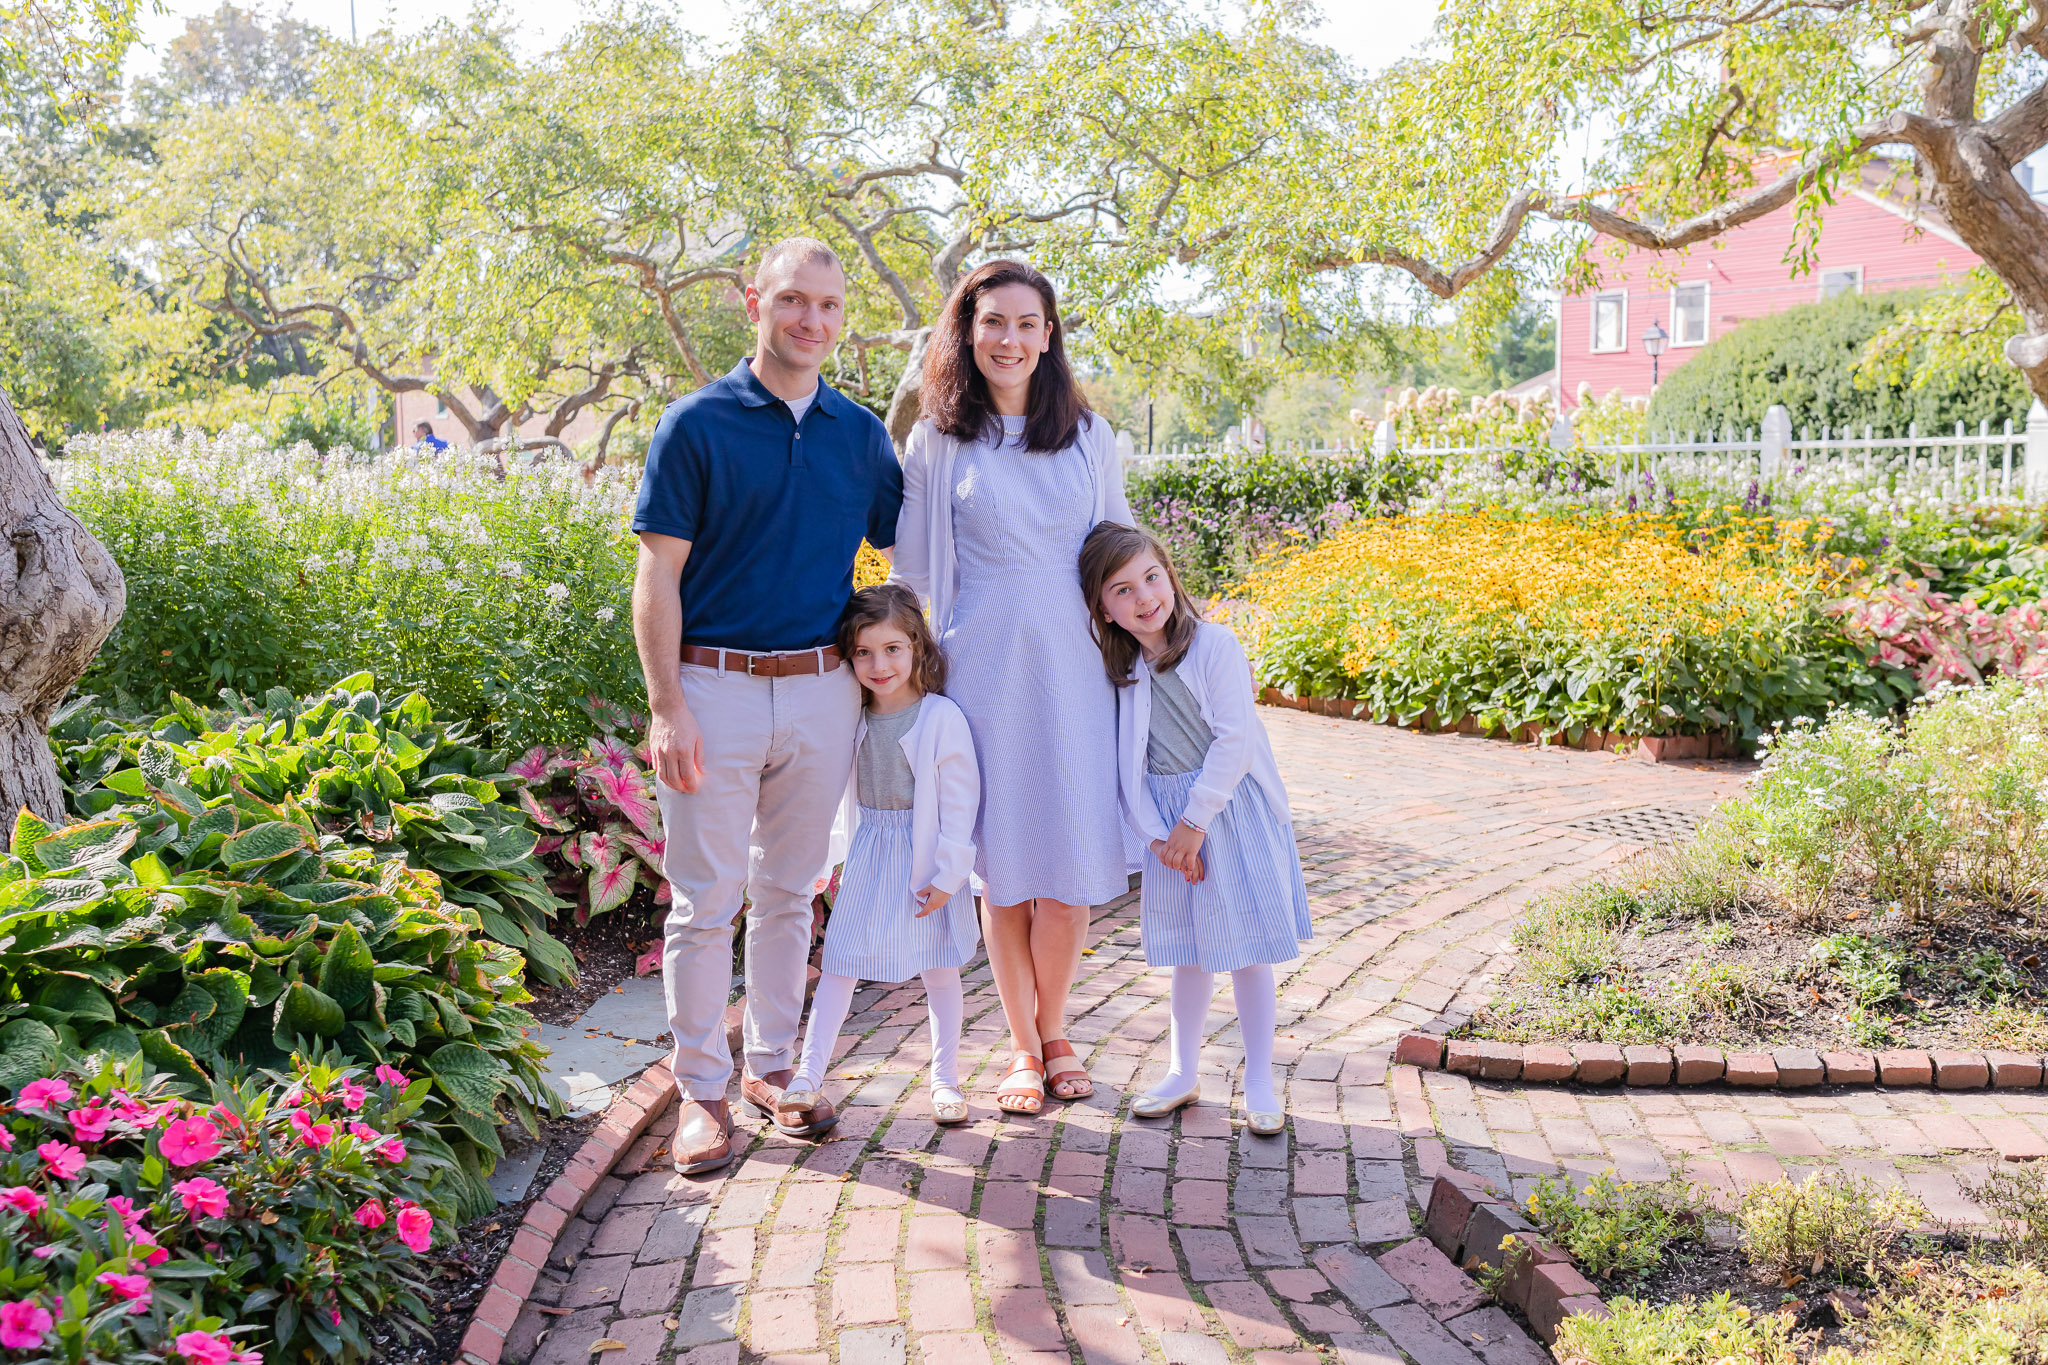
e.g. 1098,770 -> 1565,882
1395,1033 -> 2044,1091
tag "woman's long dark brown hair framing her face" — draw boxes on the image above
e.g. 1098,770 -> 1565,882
922,260 -> 1087,450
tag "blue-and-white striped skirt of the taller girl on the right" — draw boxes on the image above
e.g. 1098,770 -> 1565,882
1139,772 -> 1313,972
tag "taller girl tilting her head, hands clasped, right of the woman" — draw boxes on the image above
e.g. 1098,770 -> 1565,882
1081,522 -> 1311,1136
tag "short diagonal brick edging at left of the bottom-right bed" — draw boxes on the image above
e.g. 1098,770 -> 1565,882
1421,1171 -> 1608,1347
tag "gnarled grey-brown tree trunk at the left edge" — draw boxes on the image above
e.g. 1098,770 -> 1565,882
0,389 -> 127,826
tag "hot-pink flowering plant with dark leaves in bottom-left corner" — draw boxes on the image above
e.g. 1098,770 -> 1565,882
0,1058 -> 449,1365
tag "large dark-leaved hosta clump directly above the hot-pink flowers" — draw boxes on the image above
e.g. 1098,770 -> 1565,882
0,776 -> 555,1214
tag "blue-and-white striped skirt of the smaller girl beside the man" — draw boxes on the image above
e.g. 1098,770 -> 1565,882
817,806 -> 981,980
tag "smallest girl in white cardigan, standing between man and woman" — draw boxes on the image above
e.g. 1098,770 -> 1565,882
776,583 -> 981,1124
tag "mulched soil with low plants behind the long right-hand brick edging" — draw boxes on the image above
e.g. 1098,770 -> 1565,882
1468,888 -> 2048,1052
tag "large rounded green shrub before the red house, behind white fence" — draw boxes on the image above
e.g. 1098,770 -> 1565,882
1649,291 -> 2030,436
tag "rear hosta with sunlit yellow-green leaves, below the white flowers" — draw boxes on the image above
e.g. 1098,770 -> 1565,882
53,673 -> 575,984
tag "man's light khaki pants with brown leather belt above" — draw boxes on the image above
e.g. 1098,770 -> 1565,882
655,663 -> 860,1099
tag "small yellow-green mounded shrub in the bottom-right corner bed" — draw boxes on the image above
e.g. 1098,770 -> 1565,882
1737,1171 -> 1927,1279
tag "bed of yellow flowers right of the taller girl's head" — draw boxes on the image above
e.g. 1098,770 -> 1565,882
1239,510 -> 1878,737
